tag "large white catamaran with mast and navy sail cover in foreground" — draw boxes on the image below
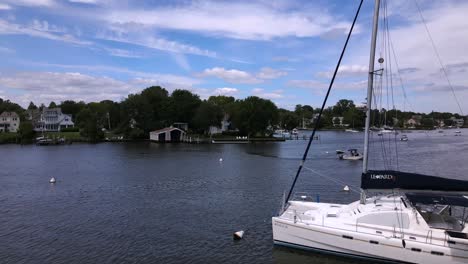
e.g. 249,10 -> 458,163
272,0 -> 468,264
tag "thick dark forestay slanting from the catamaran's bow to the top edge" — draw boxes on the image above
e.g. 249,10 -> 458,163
286,0 -> 364,202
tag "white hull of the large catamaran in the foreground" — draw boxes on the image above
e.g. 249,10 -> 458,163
272,199 -> 468,264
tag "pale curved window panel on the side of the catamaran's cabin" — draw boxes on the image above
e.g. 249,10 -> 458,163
358,212 -> 409,229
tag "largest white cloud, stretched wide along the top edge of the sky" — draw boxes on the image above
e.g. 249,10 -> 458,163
104,1 -> 350,40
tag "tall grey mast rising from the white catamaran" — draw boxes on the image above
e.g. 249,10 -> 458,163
362,0 -> 380,173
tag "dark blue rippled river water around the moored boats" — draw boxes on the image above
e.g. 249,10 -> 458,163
0,131 -> 468,263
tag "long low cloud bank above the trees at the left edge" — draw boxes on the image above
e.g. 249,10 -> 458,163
0,72 -> 201,106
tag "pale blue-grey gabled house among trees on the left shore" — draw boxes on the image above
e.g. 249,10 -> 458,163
27,107 -> 75,132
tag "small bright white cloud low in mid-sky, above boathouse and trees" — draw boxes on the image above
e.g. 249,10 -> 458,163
196,67 -> 262,84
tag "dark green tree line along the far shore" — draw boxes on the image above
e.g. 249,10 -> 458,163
0,86 -> 460,141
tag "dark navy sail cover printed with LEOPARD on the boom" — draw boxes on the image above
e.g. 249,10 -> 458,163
361,170 -> 468,192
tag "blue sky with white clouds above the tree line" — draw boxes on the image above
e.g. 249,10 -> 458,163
0,0 -> 468,114
